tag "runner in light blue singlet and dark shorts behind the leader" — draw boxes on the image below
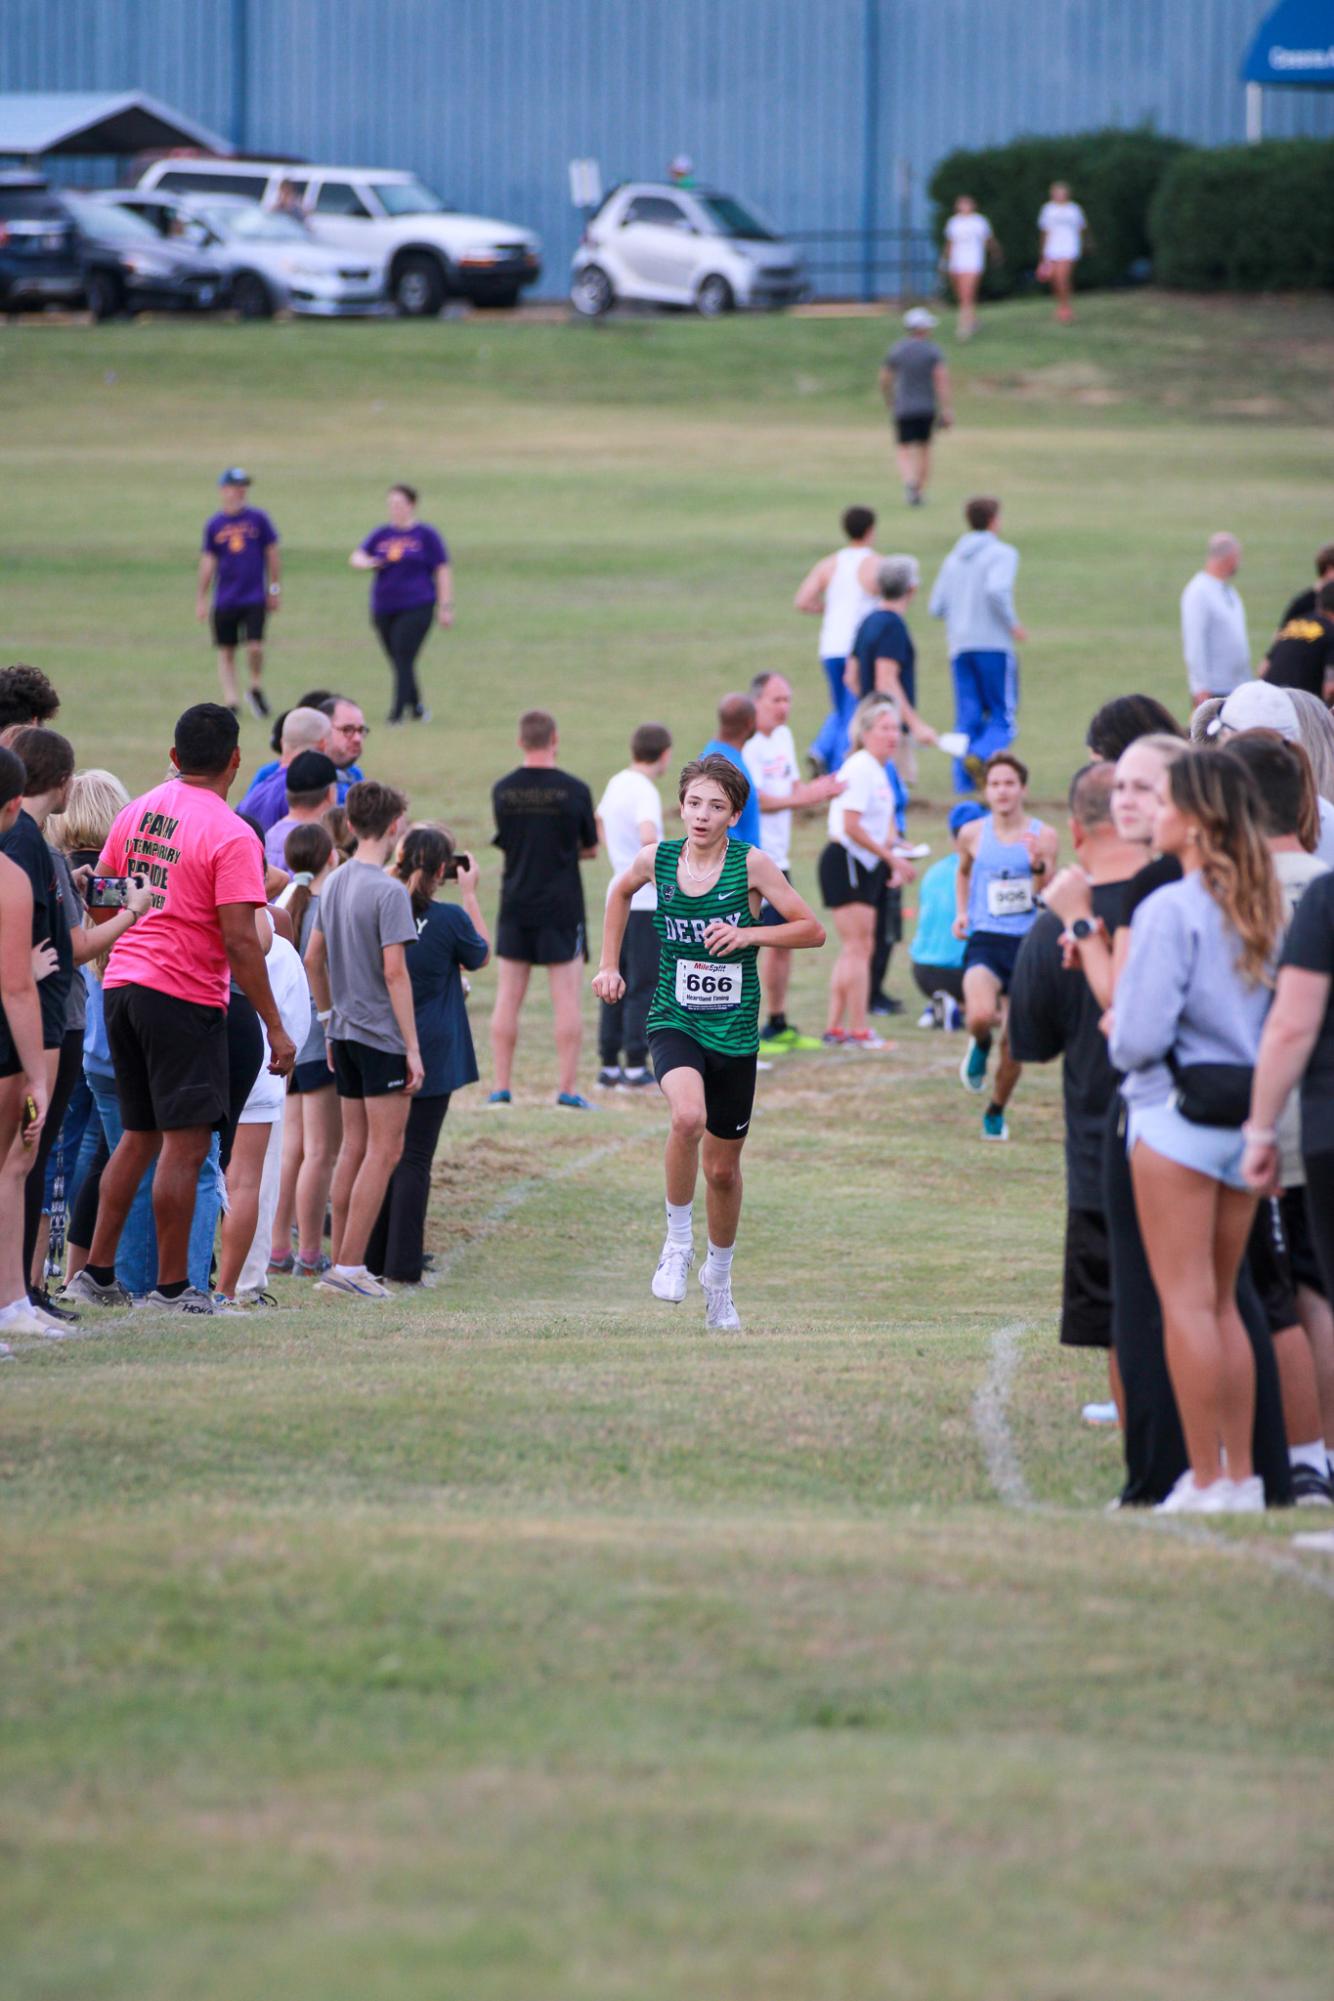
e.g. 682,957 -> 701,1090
954,750 -> 1060,1139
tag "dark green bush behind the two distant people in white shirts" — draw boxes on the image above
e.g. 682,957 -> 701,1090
928,130 -> 1192,298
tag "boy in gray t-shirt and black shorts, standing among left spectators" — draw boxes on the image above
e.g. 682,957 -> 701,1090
306,778 -> 422,1299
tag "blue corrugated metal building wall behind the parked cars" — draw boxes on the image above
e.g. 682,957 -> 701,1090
0,0 -> 1334,290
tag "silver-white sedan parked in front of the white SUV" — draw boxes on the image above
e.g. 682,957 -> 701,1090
104,188 -> 384,320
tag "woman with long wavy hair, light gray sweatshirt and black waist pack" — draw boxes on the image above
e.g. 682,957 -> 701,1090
1110,748 -> 1282,1513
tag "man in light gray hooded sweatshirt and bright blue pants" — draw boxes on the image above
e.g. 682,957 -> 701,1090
930,498 -> 1028,792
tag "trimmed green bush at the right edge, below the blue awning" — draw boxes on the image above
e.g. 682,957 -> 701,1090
1148,138 -> 1334,292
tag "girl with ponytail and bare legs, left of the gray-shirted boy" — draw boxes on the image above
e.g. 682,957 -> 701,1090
268,820 -> 342,1279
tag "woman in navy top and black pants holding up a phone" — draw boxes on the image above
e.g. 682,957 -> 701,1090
366,826 -> 490,1285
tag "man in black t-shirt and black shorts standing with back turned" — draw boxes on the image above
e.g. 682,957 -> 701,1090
488,708 -> 598,1111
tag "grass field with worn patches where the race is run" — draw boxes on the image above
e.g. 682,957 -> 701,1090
0,296 -> 1334,2001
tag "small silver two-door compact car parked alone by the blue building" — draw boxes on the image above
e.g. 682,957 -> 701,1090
570,180 -> 810,318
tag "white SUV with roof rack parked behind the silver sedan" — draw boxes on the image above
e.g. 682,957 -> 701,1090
136,158 -> 542,318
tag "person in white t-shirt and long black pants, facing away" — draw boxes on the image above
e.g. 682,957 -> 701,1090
596,722 -> 672,1091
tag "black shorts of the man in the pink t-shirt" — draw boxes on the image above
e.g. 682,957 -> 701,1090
102,986 -> 230,1133
